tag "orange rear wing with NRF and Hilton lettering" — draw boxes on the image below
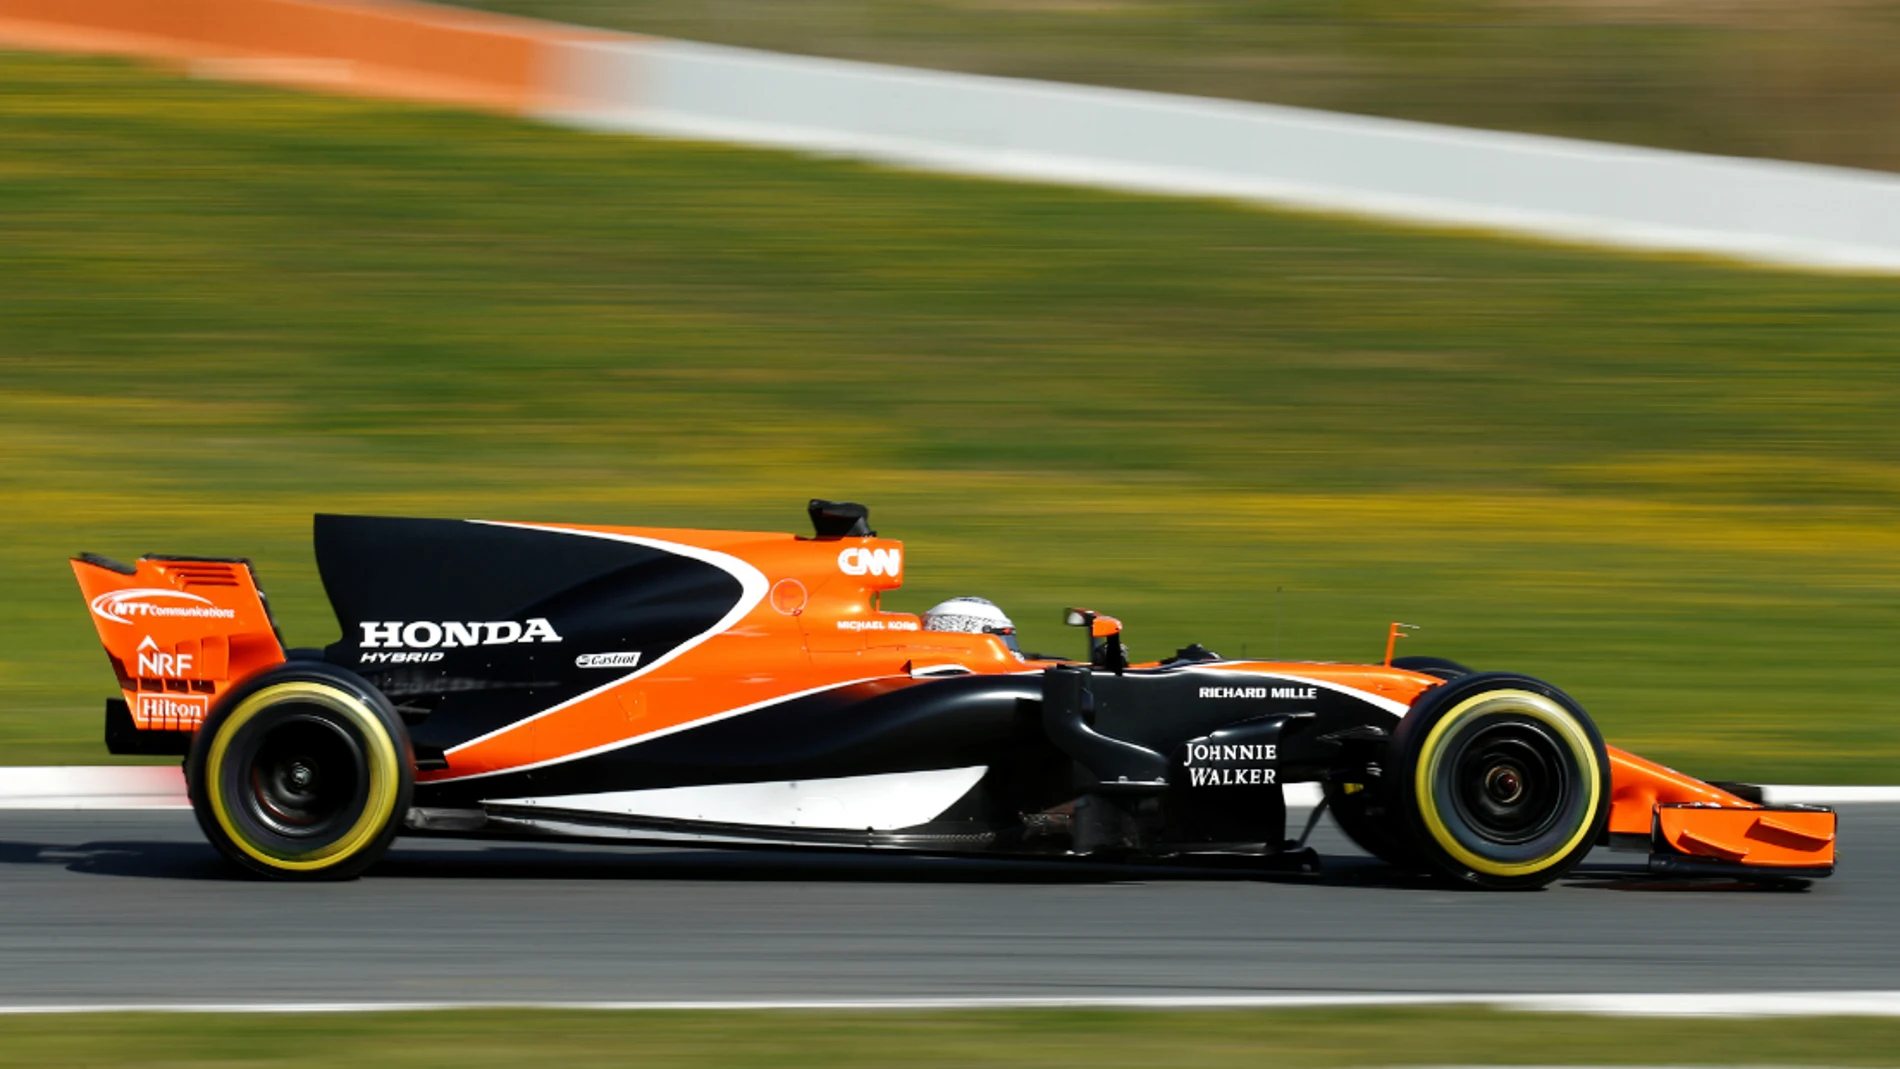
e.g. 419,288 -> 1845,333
72,553 -> 283,752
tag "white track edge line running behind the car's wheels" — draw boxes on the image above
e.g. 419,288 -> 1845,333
0,765 -> 1900,809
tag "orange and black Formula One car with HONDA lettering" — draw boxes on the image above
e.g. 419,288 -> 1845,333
72,501 -> 1835,889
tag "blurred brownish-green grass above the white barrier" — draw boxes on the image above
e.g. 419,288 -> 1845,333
462,0 -> 1900,169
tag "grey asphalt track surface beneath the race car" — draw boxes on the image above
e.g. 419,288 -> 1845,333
0,805 -> 1900,1006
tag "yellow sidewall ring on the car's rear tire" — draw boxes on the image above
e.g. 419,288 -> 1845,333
203,682 -> 401,872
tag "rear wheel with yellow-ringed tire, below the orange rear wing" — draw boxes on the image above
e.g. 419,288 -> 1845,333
186,661 -> 414,879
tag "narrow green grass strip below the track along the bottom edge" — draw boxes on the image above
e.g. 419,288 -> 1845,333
0,1010 -> 1900,1069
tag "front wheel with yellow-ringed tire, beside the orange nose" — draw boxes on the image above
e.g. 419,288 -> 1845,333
1387,672 -> 1609,891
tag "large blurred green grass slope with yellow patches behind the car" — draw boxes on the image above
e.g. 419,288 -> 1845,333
0,55 -> 1900,782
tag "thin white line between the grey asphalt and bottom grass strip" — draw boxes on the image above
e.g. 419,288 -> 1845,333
0,991 -> 1900,1018
